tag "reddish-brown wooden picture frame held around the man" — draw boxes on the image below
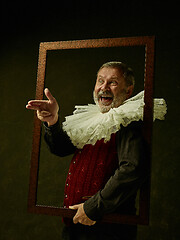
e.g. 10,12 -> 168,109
28,36 -> 155,225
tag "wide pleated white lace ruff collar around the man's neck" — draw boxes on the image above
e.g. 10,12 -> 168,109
63,91 -> 167,149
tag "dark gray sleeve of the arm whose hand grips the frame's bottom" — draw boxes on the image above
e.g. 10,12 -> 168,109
84,123 -> 148,221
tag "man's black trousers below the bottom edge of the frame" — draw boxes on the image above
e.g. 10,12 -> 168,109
62,223 -> 137,240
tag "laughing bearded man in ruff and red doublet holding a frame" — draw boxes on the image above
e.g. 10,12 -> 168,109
26,62 -> 148,240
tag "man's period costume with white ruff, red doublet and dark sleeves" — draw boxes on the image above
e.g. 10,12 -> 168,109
45,92 -> 166,239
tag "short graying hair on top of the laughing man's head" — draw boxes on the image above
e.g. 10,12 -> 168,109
97,61 -> 135,86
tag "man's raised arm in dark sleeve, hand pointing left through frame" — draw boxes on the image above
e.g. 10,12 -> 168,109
26,88 -> 76,157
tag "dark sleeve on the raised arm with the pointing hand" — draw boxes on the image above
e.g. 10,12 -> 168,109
44,121 -> 76,157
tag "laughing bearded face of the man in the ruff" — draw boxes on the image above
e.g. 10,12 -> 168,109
94,67 -> 128,113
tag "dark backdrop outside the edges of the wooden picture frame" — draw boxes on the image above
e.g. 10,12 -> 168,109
0,0 -> 180,240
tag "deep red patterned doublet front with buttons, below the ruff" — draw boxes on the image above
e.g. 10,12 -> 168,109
64,134 -> 118,208
